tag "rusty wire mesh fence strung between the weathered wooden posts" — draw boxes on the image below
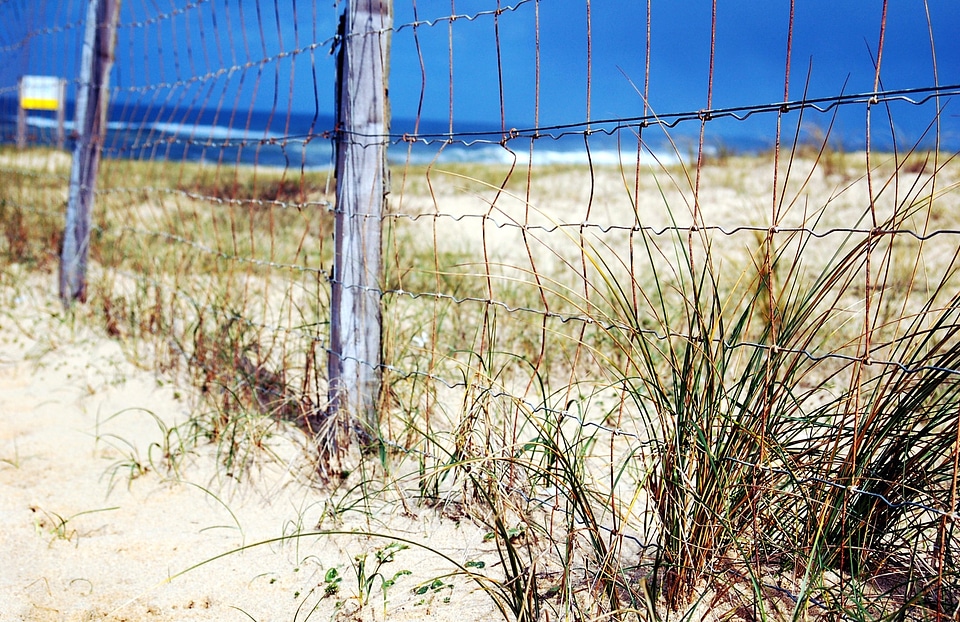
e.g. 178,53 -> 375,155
0,0 -> 960,619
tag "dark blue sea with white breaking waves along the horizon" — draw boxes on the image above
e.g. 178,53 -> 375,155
0,99 -> 944,170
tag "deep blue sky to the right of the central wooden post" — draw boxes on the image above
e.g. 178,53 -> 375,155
391,0 -> 960,140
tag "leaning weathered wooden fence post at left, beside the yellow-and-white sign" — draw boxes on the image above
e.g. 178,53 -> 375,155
60,0 -> 120,306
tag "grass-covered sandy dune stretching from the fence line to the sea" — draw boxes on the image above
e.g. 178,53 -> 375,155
0,142 -> 960,621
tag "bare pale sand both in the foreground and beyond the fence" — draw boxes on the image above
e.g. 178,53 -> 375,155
0,152 -> 957,622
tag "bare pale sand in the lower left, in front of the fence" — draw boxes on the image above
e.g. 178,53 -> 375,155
0,275 -> 499,622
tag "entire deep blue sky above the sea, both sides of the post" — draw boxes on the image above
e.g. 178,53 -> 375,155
7,0 -> 960,147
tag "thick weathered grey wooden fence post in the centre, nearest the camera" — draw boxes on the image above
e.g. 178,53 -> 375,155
326,0 -> 392,442
